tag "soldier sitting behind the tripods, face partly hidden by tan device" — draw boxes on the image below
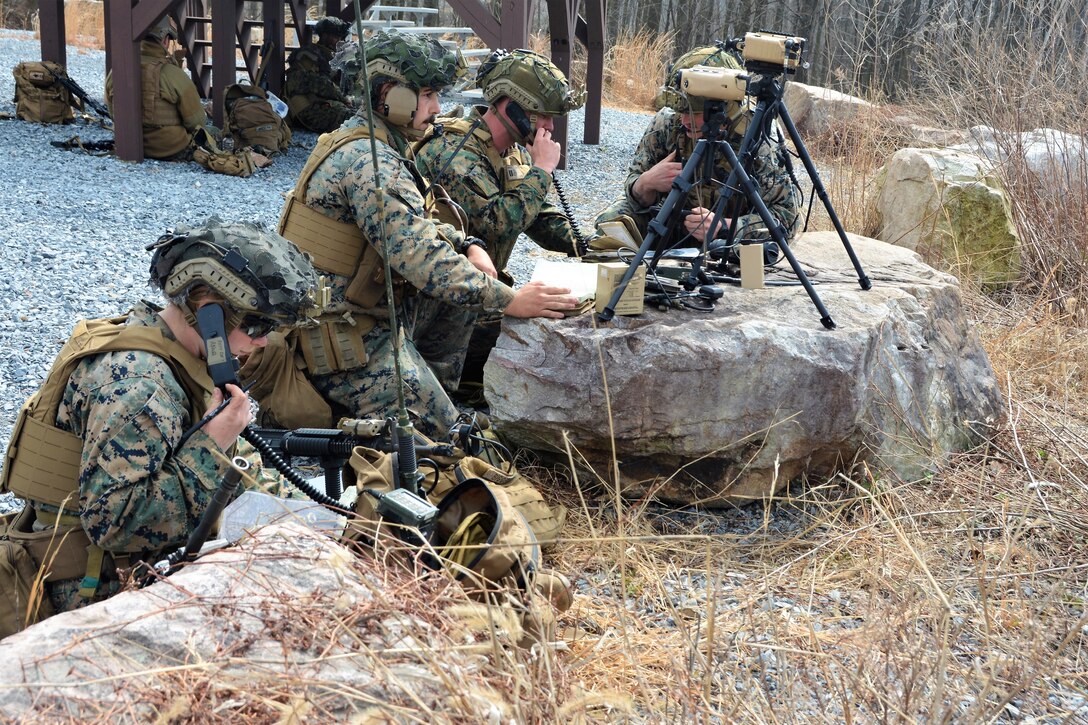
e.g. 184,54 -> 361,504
596,46 -> 801,253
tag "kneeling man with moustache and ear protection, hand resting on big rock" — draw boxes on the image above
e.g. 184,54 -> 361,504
281,32 -> 574,439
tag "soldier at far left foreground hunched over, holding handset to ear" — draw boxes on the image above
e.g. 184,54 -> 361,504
0,218 -> 317,622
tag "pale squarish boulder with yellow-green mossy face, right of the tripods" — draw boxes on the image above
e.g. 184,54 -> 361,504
876,148 -> 1021,288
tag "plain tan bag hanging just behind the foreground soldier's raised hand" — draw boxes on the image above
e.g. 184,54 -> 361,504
238,332 -> 333,429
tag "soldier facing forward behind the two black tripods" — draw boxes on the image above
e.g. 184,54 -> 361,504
596,46 -> 801,246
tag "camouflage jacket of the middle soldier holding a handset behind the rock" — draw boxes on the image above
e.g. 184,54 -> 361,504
416,107 -> 576,270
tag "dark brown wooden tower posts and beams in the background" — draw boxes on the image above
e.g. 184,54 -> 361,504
39,0 -> 605,161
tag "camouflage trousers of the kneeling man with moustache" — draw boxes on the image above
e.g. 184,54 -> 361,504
310,324 -> 459,440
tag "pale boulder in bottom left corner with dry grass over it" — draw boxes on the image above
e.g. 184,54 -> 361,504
0,523 -> 515,723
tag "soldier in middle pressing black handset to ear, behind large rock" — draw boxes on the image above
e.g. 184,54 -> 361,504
409,50 -> 585,392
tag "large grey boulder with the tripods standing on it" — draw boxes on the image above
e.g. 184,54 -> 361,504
484,233 -> 1003,506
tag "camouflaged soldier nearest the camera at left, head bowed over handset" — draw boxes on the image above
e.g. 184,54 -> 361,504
4,218 -> 316,611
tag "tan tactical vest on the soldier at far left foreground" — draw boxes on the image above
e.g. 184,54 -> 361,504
0,317 -> 214,599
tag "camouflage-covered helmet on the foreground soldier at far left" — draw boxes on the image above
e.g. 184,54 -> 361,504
147,217 -> 321,330
